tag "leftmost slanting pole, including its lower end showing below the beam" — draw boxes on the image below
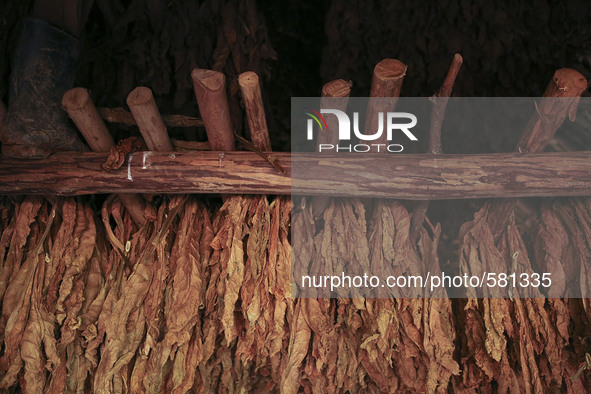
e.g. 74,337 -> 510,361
62,88 -> 146,226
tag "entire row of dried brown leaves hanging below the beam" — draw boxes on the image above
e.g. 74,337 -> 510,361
0,196 -> 591,393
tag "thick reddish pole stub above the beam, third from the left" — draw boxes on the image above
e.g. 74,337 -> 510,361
191,68 -> 235,151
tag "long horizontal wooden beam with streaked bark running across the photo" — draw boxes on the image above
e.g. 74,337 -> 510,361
0,151 -> 591,200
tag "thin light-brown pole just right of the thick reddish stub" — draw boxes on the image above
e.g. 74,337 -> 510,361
238,71 -> 271,152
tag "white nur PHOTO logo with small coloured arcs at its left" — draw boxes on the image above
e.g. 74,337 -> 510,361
305,109 -> 418,153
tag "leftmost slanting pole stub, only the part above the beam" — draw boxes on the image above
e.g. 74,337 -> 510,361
62,88 -> 115,152
